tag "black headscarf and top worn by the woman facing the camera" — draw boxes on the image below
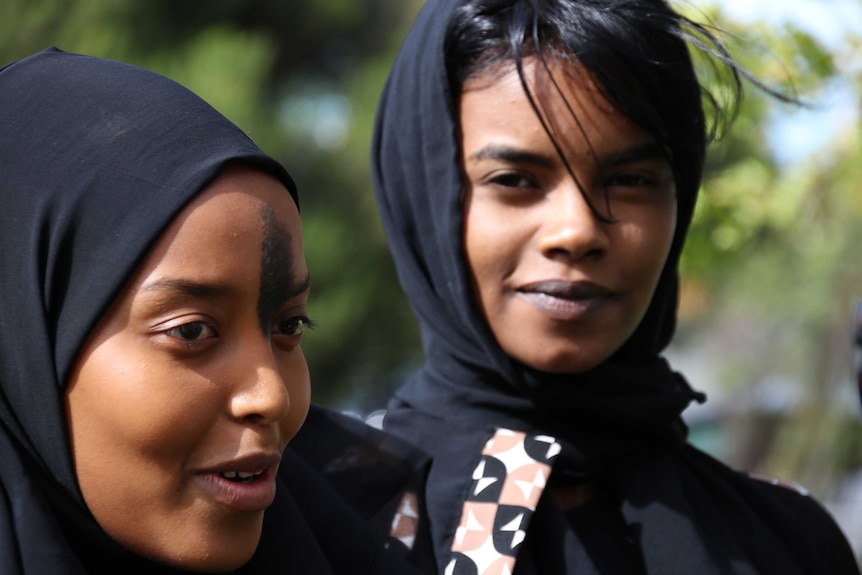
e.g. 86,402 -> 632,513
372,0 -> 859,575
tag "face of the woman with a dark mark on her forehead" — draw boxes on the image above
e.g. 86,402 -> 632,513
66,167 -> 310,571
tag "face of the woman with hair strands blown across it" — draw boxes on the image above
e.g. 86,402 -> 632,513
460,60 -> 676,373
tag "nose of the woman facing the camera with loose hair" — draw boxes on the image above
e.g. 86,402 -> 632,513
538,181 -> 609,261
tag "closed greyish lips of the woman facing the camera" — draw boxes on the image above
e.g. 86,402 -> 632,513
517,280 -> 617,321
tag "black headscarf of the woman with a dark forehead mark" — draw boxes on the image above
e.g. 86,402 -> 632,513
0,48 -> 416,575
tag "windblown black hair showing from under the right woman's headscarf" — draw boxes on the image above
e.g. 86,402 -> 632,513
445,0 -> 748,227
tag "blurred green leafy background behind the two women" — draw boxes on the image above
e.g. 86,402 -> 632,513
0,0 -> 862,555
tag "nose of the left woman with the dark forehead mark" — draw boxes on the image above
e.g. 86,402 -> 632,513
230,345 -> 290,425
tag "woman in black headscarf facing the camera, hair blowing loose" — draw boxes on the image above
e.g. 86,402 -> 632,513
373,0 -> 859,575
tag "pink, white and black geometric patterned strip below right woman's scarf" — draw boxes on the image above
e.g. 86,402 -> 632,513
444,428 -> 560,575
